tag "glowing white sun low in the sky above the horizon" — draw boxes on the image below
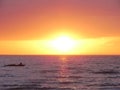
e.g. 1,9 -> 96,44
52,36 -> 75,52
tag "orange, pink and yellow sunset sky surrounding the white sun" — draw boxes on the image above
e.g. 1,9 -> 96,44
0,0 -> 120,55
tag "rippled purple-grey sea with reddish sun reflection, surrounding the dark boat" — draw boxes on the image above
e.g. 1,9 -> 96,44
0,56 -> 120,90
